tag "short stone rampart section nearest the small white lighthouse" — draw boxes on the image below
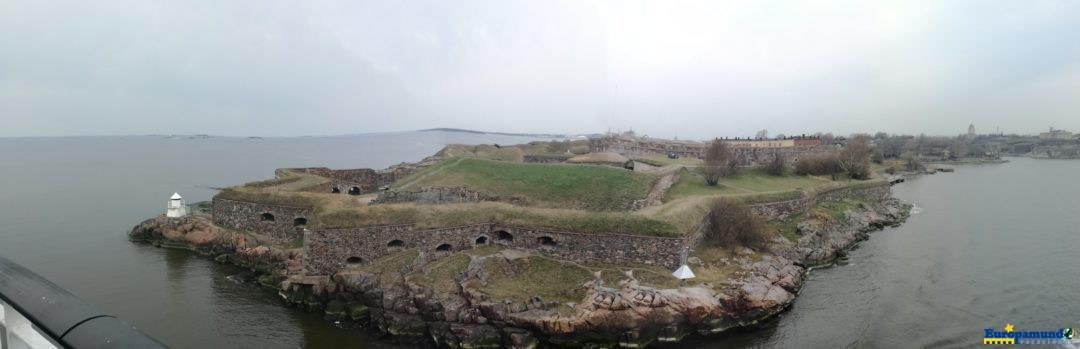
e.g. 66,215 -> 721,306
212,198 -> 311,243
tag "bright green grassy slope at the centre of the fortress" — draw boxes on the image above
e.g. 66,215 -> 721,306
395,158 -> 656,211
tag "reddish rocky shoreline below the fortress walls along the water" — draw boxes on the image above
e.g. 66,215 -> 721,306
129,198 -> 910,348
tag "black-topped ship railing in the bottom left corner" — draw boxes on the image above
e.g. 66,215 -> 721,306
0,257 -> 164,348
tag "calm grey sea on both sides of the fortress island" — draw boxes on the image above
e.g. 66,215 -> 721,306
0,132 -> 1080,348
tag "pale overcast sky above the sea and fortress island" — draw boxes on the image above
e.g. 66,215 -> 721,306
0,0 -> 1080,138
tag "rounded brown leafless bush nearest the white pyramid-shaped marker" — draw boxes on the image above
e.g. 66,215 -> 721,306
705,198 -> 769,247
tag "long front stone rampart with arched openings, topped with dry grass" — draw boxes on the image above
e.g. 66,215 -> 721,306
303,224 -> 686,274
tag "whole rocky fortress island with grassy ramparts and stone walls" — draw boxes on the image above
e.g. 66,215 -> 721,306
130,135 -> 910,348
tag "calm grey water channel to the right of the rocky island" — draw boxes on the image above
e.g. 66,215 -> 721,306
692,159 -> 1080,348
